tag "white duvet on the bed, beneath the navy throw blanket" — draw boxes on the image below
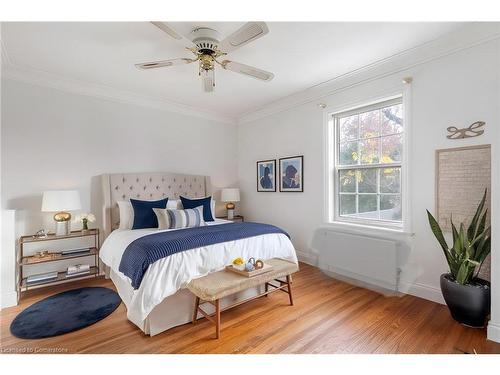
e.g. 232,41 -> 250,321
99,219 -> 297,321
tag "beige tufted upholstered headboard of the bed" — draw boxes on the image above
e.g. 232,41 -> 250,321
98,172 -> 212,238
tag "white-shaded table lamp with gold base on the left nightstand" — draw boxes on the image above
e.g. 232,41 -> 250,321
42,190 -> 82,236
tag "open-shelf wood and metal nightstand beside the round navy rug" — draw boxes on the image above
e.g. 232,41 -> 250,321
18,229 -> 99,297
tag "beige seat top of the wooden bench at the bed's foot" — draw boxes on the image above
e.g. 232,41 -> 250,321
187,258 -> 299,301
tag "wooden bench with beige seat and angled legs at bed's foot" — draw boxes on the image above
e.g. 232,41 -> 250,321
187,258 -> 299,338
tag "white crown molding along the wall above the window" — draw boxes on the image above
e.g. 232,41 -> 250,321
237,22 -> 500,125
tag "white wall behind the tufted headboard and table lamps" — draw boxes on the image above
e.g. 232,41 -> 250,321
2,80 -> 237,235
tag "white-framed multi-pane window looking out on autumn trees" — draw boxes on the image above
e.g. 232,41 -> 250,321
330,97 -> 404,226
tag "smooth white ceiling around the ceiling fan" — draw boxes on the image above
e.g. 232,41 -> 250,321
2,22 -> 463,118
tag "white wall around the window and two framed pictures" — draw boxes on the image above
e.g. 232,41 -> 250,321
238,40 -> 500,312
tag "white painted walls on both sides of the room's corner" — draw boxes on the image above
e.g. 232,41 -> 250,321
1,31 -> 500,339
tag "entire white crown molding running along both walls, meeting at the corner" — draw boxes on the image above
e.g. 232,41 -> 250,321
1,22 -> 500,124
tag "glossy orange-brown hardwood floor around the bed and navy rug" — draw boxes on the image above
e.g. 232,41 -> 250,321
1,264 -> 500,353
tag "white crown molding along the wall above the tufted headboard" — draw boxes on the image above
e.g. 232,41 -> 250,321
2,62 -> 236,125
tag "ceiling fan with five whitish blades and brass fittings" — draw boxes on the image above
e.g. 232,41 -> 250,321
135,22 -> 274,92
